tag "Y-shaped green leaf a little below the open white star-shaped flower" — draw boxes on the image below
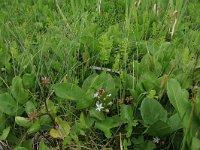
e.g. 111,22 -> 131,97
95,116 -> 122,138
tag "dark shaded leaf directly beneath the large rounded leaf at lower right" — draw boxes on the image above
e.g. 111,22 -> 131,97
147,120 -> 172,136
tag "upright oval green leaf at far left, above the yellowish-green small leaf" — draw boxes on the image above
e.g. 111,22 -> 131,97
11,77 -> 29,104
